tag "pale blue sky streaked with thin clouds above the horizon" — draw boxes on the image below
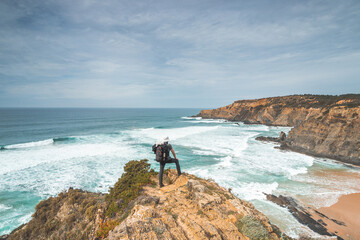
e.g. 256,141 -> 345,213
0,0 -> 360,108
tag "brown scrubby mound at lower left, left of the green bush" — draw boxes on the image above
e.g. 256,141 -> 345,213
8,188 -> 103,240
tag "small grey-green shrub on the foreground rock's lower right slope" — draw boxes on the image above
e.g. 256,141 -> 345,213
235,216 -> 269,240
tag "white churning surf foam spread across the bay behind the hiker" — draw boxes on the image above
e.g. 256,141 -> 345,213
0,118 -> 360,236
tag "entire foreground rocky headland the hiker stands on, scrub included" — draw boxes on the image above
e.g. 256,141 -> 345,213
0,160 -> 289,240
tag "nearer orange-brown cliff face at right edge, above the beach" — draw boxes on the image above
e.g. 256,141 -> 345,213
286,106 -> 360,165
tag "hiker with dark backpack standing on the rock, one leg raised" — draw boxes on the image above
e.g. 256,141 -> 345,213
153,137 -> 181,187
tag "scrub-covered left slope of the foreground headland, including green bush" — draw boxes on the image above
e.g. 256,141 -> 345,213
8,159 -> 157,240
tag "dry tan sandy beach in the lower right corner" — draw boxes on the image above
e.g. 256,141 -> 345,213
318,193 -> 360,240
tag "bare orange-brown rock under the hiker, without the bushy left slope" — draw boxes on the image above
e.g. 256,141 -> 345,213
108,171 -> 281,240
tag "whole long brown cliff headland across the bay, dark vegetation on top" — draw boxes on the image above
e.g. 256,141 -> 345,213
197,94 -> 360,165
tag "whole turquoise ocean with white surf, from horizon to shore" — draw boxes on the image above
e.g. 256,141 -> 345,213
0,108 -> 360,237
